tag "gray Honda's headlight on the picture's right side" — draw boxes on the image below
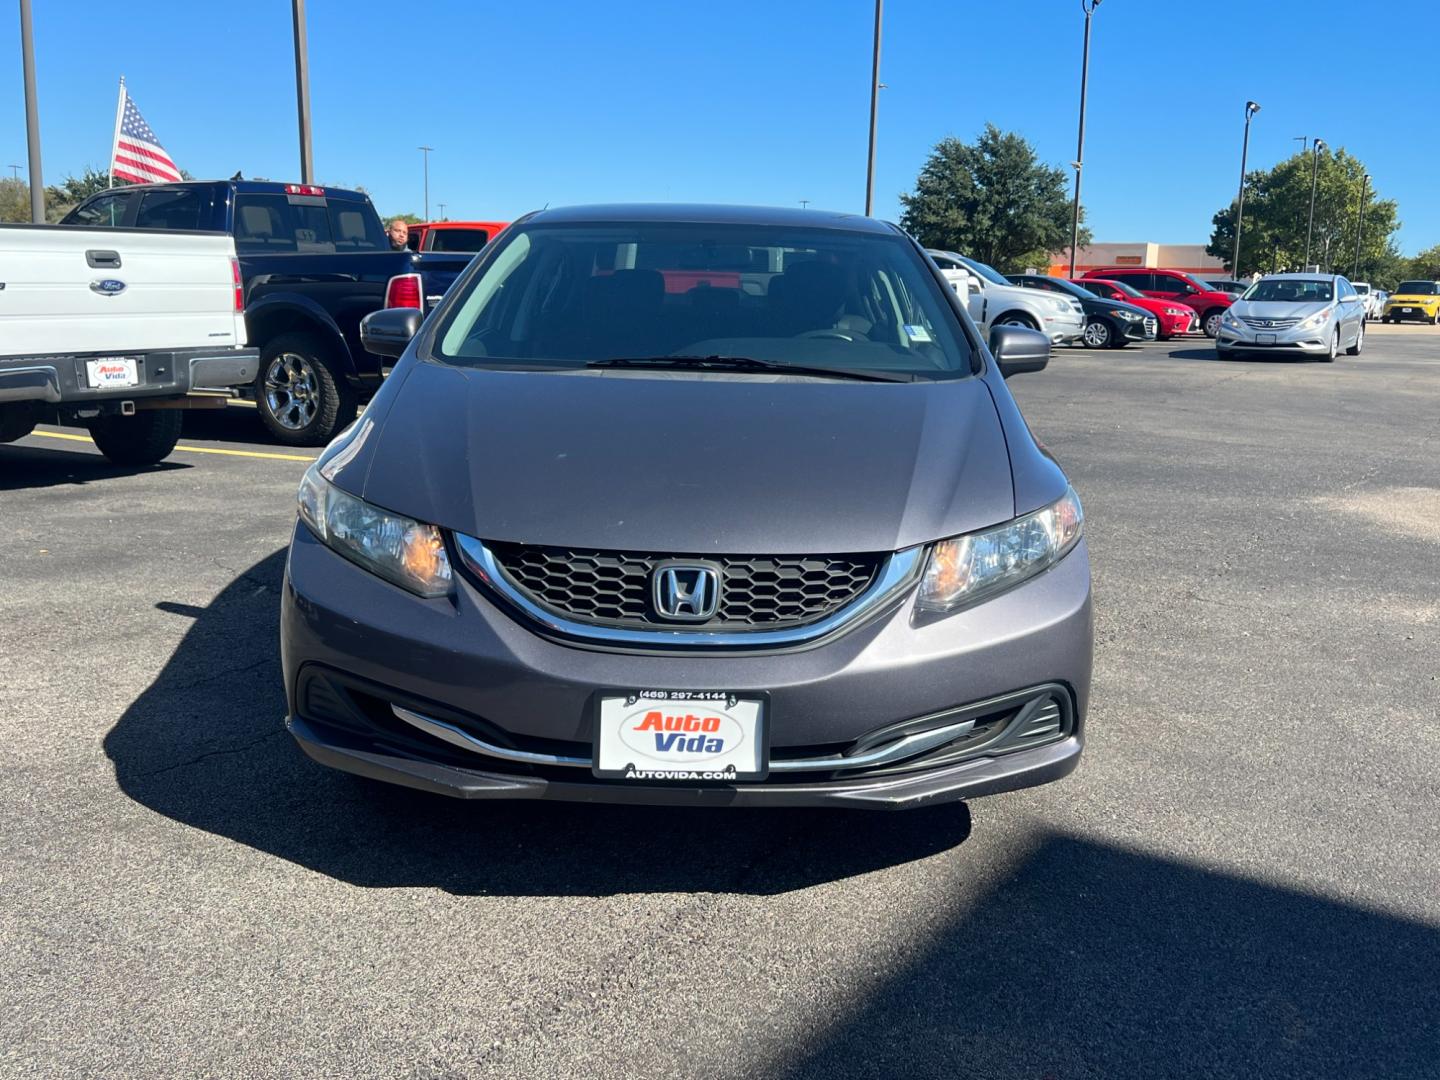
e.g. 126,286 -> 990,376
916,488 -> 1084,611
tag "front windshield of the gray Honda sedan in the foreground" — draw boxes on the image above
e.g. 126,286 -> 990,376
435,222 -> 972,379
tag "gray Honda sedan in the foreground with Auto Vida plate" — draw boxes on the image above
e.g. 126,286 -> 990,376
281,206 -> 1093,809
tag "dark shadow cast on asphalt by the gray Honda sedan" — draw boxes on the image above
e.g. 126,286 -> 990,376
105,550 -> 971,896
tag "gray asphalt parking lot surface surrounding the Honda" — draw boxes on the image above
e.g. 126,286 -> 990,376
0,325 -> 1440,1080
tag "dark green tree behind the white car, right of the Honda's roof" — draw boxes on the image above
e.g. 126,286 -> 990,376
900,124 -> 1090,272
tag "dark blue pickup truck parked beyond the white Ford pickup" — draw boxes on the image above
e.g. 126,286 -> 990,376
60,180 -> 472,446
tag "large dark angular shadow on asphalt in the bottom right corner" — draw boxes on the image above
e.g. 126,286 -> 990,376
777,834 -> 1440,1080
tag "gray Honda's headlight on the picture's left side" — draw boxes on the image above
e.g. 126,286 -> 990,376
300,462 -> 451,596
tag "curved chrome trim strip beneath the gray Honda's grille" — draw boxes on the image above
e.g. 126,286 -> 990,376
454,533 -> 926,649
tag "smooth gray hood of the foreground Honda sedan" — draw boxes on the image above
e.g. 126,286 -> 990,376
349,361 -> 1015,554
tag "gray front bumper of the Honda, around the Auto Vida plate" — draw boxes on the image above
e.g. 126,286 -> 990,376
281,527 -> 1093,808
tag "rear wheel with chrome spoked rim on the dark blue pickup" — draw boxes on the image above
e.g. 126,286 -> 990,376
255,334 -> 356,446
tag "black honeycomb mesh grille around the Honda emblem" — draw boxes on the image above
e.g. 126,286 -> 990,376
490,544 -> 881,631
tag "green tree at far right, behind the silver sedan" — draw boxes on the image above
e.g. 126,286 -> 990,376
1205,147 -> 1400,285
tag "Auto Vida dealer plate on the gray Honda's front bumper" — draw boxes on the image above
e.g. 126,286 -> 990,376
592,690 -> 769,783
